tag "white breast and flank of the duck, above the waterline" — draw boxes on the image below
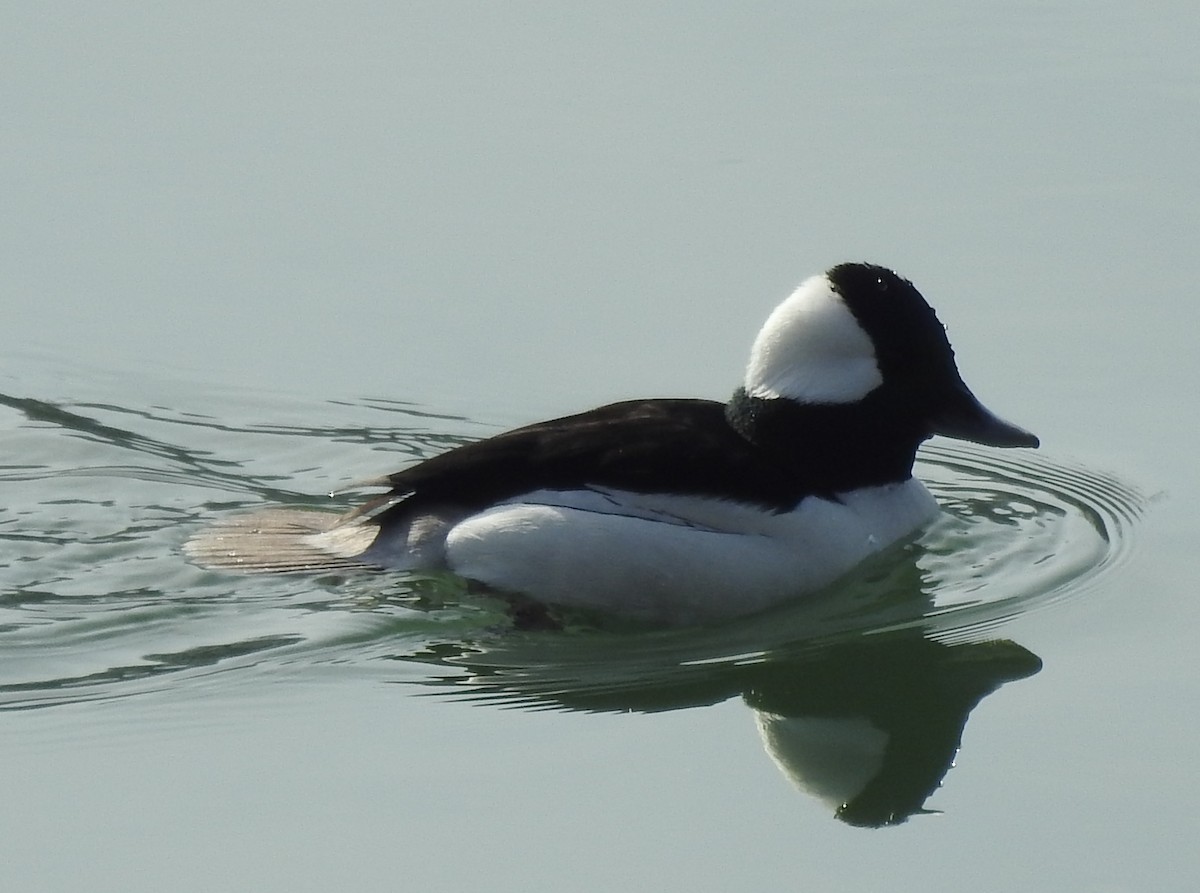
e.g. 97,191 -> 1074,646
445,479 -> 937,624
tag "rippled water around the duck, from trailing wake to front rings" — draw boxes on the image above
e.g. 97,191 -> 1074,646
0,376 -> 1146,709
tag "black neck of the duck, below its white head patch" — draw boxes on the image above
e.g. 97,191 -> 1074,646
725,388 -> 928,492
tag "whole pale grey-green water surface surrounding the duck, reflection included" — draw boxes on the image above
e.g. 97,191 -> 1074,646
0,2 -> 1200,891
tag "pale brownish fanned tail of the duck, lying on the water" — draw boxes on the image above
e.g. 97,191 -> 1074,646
184,509 -> 379,574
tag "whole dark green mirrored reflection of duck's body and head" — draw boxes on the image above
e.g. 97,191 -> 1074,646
367,543 -> 1042,827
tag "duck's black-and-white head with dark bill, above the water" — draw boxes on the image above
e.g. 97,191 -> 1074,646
744,263 -> 1038,447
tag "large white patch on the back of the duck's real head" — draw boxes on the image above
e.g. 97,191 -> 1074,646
745,275 -> 883,403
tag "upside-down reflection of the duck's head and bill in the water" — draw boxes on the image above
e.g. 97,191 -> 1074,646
744,635 -> 1042,827
